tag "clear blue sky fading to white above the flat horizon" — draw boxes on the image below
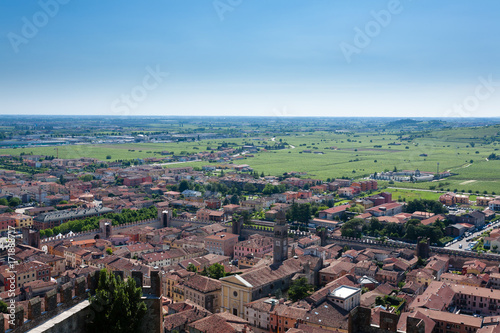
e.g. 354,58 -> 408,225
0,0 -> 500,117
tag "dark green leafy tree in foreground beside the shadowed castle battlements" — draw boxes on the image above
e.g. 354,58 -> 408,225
89,269 -> 147,333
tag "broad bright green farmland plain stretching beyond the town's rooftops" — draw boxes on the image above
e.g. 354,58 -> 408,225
0,126 -> 500,194
